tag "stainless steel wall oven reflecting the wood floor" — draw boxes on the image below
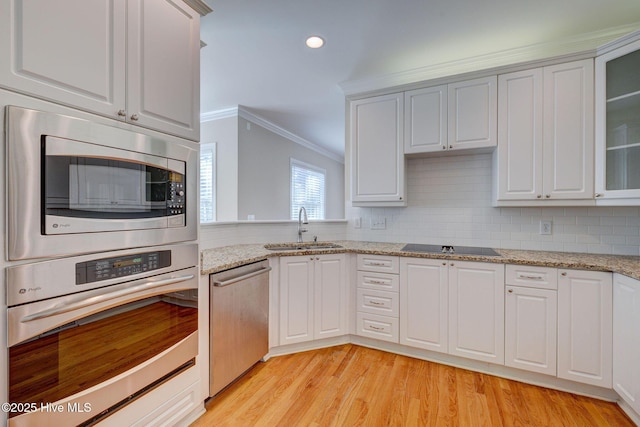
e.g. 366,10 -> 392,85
6,243 -> 199,426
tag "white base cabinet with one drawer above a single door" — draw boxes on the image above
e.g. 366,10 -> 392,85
504,264 -> 558,376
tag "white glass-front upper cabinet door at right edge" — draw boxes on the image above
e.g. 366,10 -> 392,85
596,34 -> 640,204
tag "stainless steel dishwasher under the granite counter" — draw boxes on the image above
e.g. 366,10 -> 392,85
209,261 -> 271,396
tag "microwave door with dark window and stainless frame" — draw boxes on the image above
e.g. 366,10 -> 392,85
43,136 -> 185,235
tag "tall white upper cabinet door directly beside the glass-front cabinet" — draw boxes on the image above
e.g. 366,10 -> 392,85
543,59 -> 594,199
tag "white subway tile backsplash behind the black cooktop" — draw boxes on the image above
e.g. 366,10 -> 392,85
346,154 -> 640,256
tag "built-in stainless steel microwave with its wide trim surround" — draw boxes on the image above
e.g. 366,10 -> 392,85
6,106 -> 198,260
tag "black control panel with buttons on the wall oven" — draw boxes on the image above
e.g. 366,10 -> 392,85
76,251 -> 171,285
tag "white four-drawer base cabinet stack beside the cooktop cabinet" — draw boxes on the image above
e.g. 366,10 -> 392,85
356,254 -> 400,343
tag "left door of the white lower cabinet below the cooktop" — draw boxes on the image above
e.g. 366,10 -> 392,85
400,258 -> 448,353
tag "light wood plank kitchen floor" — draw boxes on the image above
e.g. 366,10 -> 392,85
192,344 -> 634,427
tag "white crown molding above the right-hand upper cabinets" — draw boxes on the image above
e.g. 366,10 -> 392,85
339,23 -> 640,96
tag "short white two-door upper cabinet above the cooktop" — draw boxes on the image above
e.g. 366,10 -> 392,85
404,76 -> 497,154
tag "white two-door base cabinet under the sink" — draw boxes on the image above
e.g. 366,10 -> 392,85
279,254 -> 348,345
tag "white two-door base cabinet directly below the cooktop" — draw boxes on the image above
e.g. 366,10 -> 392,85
400,258 -> 504,364
